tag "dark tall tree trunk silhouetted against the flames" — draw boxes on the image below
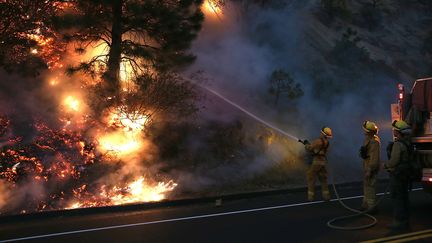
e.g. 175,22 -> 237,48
105,0 -> 123,95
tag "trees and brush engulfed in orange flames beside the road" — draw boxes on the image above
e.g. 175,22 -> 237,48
0,1 -> 208,214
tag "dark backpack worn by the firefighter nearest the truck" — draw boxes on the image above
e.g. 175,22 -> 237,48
395,140 -> 423,181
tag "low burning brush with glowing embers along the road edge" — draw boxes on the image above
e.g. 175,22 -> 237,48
0,107 -> 176,212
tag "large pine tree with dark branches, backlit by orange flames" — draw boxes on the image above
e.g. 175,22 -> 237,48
57,0 -> 203,96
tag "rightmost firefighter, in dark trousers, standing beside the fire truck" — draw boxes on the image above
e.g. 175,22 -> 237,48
384,120 -> 411,231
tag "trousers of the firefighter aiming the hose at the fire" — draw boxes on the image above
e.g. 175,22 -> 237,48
306,163 -> 330,201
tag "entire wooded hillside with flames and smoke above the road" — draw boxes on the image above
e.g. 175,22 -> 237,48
5,0 -> 422,214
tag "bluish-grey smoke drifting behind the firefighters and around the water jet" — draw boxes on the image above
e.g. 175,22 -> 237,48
183,1 -> 402,186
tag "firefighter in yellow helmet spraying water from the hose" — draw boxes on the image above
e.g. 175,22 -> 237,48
305,127 -> 332,201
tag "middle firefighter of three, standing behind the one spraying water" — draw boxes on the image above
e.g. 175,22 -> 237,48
360,121 -> 381,212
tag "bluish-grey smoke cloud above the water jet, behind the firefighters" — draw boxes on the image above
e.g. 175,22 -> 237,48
186,1 -> 395,183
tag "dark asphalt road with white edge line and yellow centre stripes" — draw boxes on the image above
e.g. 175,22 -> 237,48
0,183 -> 432,243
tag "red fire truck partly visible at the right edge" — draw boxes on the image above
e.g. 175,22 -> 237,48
391,77 -> 432,193
